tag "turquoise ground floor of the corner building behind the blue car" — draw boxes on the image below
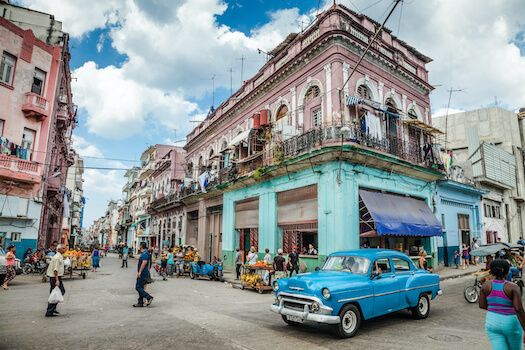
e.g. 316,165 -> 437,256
222,161 -> 442,271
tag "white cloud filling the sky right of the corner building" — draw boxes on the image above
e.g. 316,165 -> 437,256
342,0 -> 525,110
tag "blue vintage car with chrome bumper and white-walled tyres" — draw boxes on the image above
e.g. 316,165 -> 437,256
270,249 -> 441,338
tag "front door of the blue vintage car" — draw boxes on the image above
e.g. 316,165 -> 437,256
372,258 -> 399,317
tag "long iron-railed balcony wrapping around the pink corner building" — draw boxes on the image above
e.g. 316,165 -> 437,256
180,123 -> 444,198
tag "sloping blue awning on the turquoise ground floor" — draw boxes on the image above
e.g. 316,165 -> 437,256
359,190 -> 443,237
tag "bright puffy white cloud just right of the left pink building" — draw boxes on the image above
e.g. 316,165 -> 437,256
72,62 -> 198,139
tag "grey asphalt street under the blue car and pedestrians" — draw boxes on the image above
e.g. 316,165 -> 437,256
0,254 -> 490,350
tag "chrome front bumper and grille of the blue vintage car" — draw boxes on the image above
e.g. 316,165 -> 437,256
270,293 -> 340,324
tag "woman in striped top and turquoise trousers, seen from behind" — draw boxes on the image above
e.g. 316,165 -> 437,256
479,259 -> 525,350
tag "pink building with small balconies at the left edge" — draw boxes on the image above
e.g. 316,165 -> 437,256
0,18 -> 75,253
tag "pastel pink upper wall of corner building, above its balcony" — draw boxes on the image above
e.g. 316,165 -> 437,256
185,6 -> 432,174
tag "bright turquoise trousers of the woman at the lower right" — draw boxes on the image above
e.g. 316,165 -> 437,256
485,311 -> 523,350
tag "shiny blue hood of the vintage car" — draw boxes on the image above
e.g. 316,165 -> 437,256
287,271 -> 367,292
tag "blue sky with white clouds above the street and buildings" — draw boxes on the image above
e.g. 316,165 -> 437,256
14,0 -> 525,227
